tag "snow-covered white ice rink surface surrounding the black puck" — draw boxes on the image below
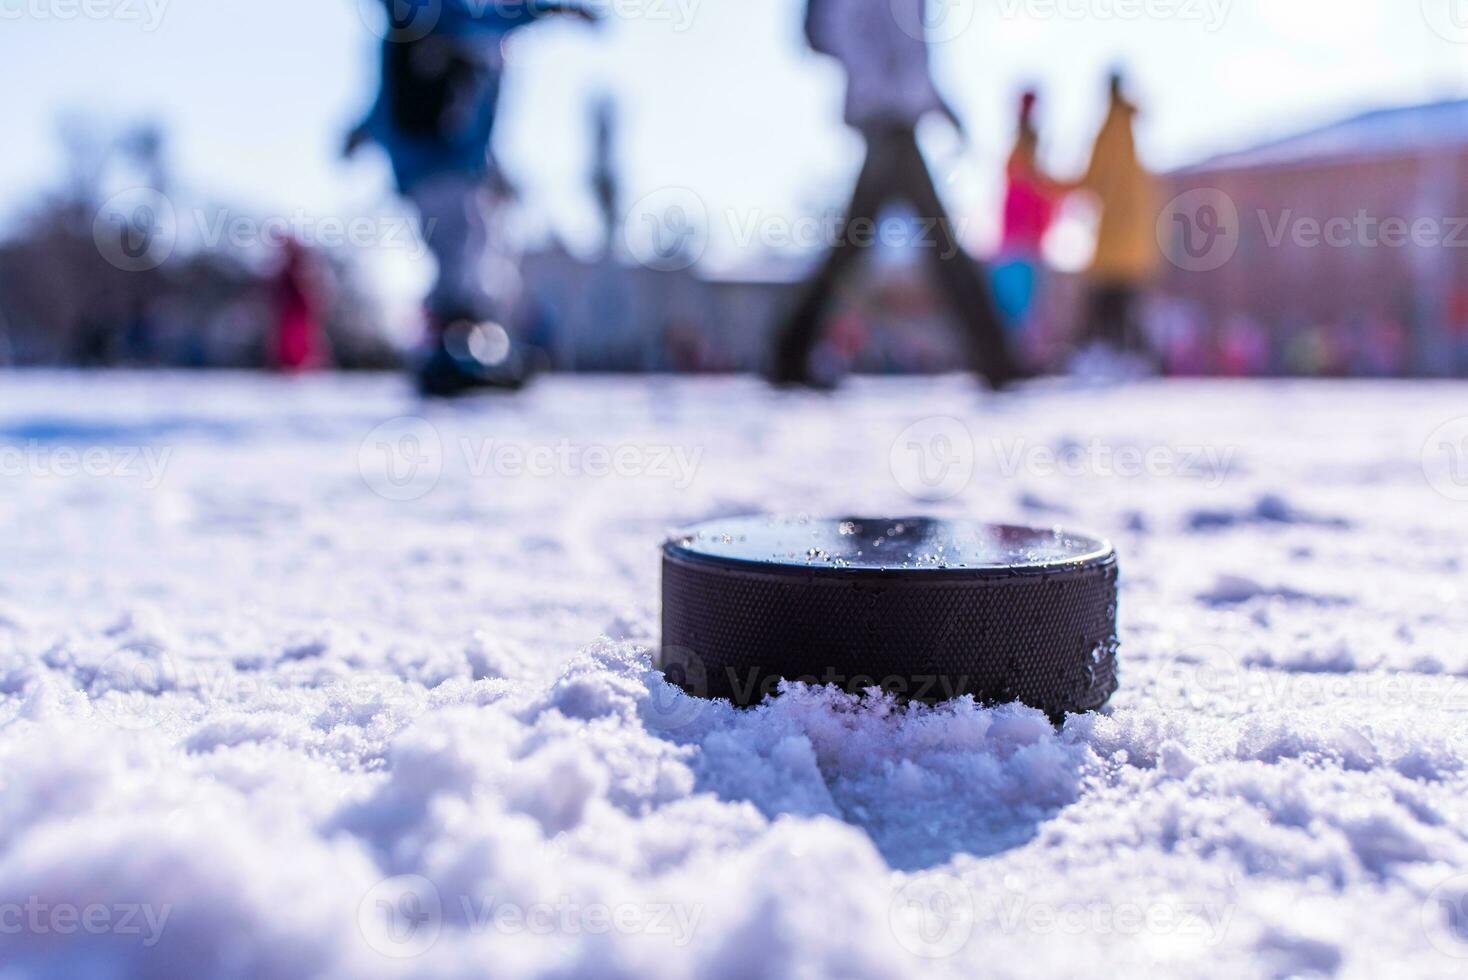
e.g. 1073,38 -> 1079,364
0,374 -> 1468,979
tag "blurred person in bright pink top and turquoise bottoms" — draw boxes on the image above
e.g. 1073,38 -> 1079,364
994,89 -> 1067,362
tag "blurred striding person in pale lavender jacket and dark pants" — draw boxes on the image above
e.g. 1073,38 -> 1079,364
769,0 -> 1020,387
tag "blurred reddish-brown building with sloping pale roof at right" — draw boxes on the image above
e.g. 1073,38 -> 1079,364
1158,100 -> 1468,376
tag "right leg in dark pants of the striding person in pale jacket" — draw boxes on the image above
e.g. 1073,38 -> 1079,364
894,129 -> 1020,387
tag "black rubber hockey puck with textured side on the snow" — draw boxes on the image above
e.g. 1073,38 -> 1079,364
659,516 -> 1117,719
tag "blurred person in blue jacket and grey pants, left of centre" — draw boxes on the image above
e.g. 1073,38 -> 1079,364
345,0 -> 595,396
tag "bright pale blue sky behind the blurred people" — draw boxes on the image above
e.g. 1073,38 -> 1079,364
0,0 -> 1468,294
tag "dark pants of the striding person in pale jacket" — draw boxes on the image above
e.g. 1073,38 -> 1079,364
774,128 -> 1019,384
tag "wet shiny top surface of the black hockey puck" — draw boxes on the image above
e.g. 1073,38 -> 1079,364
665,516 -> 1111,575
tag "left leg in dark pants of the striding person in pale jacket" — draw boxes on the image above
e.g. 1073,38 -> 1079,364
771,136 -> 890,381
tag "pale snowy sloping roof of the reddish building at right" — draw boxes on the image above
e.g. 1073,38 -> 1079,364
1179,98 -> 1468,173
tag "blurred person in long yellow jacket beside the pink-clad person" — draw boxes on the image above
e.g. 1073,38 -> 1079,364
1076,73 -> 1160,355
